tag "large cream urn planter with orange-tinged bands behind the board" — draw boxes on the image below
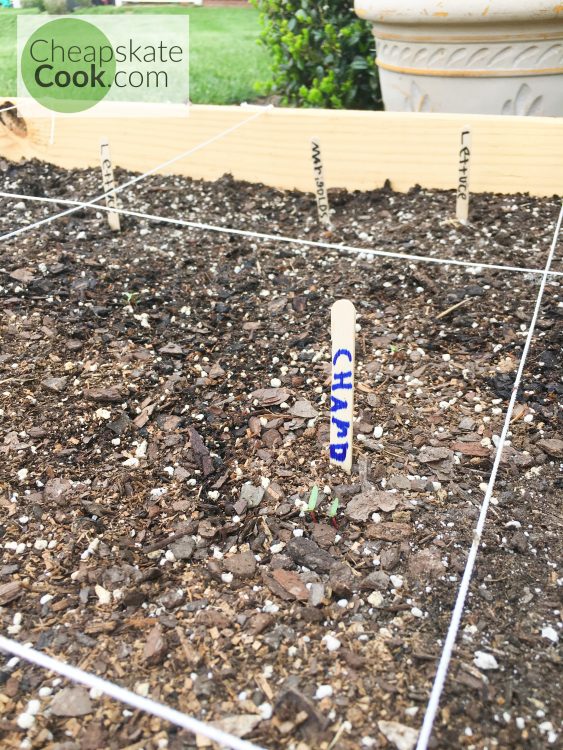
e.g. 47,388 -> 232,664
355,0 -> 563,116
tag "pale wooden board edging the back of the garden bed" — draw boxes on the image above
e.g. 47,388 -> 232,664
0,98 -> 563,196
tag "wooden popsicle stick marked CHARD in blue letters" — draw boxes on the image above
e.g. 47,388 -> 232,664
330,299 -> 356,474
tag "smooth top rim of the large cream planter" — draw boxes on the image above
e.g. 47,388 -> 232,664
354,0 -> 563,28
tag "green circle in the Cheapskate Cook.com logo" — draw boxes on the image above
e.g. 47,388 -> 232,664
21,18 -> 116,113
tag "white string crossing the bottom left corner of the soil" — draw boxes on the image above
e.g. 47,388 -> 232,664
0,635 -> 265,750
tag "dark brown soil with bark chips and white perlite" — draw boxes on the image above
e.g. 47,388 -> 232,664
0,162 -> 563,750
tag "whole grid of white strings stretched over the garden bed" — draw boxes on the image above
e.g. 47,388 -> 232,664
0,107 -> 563,750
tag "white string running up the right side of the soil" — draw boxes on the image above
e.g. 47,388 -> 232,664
416,205 -> 563,750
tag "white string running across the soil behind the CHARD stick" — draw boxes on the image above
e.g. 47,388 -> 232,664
0,191 -> 563,276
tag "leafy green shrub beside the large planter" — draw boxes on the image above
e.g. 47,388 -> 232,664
252,0 -> 381,109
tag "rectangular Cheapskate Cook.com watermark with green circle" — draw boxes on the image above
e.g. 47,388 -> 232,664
18,15 -> 189,116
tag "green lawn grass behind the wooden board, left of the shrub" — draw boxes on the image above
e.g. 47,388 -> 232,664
0,6 -> 269,104
